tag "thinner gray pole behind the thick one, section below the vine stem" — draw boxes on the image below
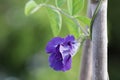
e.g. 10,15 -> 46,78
80,39 -> 92,80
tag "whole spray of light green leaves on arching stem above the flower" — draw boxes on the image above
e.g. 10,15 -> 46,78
25,0 -> 90,38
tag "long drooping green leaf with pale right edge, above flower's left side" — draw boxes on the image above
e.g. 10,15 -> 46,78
48,8 -> 62,36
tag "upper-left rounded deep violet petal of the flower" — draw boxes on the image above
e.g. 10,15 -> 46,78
46,37 -> 64,53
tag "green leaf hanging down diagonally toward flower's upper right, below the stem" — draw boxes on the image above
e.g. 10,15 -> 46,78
64,17 -> 80,38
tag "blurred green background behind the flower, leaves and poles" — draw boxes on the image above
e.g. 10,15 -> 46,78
0,0 -> 120,80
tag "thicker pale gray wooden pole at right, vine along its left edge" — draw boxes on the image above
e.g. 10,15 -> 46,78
91,0 -> 108,80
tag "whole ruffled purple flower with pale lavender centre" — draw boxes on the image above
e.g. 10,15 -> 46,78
46,35 -> 79,71
